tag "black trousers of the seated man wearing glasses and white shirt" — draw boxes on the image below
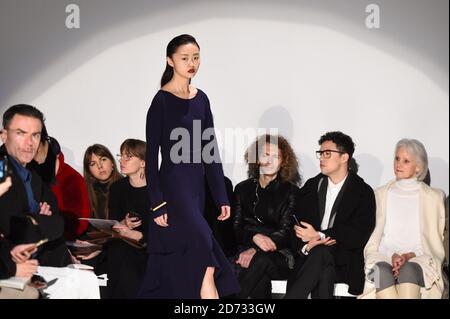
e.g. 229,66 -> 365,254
284,245 -> 337,299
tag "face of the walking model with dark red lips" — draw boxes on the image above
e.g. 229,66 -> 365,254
167,43 -> 200,79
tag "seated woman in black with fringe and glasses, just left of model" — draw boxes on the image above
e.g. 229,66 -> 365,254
107,139 -> 151,298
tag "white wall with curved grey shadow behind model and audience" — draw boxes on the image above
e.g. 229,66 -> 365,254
0,0 -> 449,193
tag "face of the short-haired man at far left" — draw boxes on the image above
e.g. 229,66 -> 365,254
2,114 -> 42,166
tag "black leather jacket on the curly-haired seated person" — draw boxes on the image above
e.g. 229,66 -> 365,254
234,178 -> 298,250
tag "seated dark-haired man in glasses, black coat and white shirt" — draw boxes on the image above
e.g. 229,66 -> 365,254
285,132 -> 375,299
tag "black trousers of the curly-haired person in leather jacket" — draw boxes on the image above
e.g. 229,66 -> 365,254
237,251 -> 289,299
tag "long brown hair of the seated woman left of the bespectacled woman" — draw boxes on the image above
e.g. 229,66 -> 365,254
83,144 -> 122,219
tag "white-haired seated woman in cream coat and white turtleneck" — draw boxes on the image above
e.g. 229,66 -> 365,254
361,139 -> 445,299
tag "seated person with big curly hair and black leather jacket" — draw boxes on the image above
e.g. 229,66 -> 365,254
234,135 -> 299,298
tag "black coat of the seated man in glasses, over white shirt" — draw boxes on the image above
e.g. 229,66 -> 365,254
293,171 -> 376,295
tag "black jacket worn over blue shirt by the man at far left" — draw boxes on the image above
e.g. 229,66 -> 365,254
0,145 -> 70,269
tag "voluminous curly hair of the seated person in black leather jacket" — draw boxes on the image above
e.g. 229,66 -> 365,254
244,134 -> 301,185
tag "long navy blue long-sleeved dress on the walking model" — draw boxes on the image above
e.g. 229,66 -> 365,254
139,90 -> 239,299
